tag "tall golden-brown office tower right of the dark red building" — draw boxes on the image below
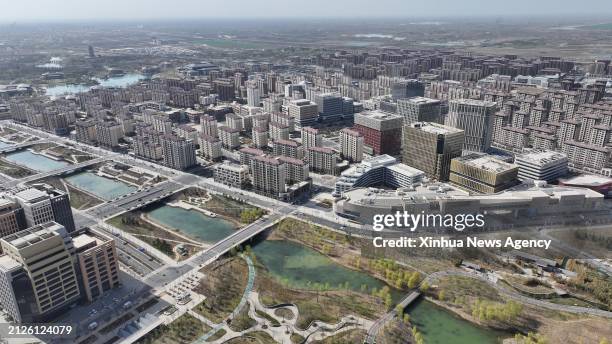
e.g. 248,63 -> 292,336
403,122 -> 464,181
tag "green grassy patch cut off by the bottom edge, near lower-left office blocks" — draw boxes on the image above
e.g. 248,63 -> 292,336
136,314 -> 211,344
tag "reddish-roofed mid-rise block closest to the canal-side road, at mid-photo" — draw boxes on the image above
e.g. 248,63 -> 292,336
250,156 -> 287,198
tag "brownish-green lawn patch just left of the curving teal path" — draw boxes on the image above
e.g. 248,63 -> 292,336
194,257 -> 248,323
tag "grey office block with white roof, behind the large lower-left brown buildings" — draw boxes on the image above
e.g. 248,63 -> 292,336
8,184 -> 75,233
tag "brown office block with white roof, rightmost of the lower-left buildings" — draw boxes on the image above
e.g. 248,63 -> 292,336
72,233 -> 119,302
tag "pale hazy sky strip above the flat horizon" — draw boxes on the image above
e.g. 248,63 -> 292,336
0,0 -> 612,22
